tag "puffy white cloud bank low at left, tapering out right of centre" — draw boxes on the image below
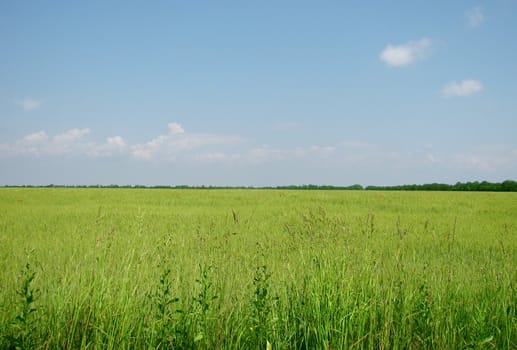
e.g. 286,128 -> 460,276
0,123 -> 335,165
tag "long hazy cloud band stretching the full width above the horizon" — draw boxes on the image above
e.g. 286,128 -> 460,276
0,123 -> 517,178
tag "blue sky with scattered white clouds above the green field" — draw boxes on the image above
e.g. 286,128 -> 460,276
0,0 -> 517,186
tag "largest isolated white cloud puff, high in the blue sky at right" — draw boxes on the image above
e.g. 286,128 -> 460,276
379,38 -> 431,67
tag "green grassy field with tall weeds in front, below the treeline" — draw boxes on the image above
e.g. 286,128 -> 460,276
0,188 -> 517,349
